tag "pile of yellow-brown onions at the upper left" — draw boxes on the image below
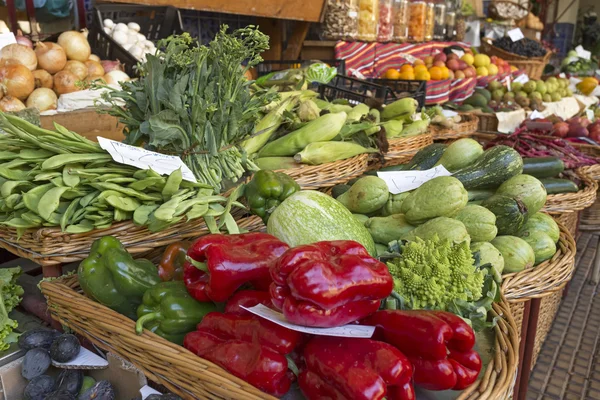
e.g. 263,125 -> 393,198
0,31 -> 129,111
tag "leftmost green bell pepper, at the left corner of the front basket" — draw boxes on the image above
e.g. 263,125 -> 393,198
77,236 -> 160,319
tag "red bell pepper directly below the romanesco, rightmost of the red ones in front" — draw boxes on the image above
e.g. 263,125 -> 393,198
362,310 -> 481,390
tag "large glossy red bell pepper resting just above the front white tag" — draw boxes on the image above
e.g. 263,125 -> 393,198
270,240 -> 393,327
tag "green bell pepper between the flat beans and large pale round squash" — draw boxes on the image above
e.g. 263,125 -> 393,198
245,170 -> 300,224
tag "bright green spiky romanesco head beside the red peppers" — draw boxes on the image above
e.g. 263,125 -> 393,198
388,235 -> 485,311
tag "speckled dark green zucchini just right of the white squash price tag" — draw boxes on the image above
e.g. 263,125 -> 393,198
452,145 -> 523,190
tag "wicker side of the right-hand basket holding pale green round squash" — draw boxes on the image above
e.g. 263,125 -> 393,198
502,221 -> 577,303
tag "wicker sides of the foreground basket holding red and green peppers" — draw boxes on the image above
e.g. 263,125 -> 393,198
41,275 -> 519,400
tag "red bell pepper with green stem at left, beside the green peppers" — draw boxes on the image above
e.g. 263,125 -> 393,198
184,232 -> 289,302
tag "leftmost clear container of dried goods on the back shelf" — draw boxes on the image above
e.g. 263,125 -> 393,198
322,0 -> 358,40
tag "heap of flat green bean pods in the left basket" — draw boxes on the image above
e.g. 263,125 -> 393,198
0,113 -> 243,233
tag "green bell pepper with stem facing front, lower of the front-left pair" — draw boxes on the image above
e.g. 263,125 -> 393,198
135,281 -> 217,345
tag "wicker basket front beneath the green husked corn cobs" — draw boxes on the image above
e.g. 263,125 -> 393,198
279,154 -> 370,190
